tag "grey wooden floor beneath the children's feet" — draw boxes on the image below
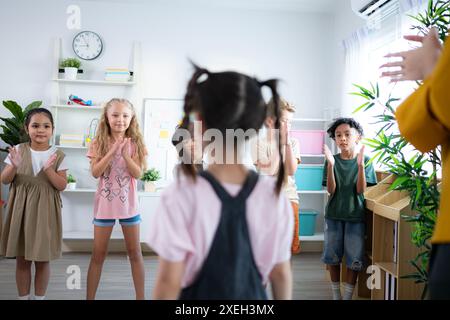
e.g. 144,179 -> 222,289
0,253 -> 331,300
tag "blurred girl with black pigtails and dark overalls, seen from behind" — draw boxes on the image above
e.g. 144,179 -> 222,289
149,67 -> 293,299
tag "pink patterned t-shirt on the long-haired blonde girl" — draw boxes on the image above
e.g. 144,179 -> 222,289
86,140 -> 138,219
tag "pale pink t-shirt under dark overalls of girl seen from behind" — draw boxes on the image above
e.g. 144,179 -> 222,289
147,172 -> 294,288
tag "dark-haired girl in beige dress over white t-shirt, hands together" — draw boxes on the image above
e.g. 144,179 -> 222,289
0,108 -> 67,300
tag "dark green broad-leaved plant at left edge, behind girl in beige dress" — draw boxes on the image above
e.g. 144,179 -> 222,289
0,100 -> 42,152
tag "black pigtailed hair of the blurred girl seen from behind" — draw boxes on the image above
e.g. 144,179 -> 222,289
179,64 -> 285,193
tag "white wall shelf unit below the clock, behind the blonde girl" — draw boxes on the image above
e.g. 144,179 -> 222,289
49,38 -> 145,240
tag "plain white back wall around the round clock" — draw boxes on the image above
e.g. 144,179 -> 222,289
0,0 -> 336,117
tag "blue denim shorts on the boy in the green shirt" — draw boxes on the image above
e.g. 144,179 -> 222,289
322,218 -> 366,271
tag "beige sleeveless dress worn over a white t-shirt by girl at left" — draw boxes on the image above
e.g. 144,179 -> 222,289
0,143 -> 65,262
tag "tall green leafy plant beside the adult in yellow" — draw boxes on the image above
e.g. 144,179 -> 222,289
351,0 -> 450,298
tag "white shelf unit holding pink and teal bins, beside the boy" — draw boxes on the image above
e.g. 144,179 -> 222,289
292,114 -> 332,248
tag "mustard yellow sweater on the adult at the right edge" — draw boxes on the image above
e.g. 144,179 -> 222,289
396,38 -> 450,243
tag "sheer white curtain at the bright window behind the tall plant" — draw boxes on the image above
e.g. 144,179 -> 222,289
340,0 -> 428,168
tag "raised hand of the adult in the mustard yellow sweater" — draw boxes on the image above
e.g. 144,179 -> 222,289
380,28 -> 442,82
